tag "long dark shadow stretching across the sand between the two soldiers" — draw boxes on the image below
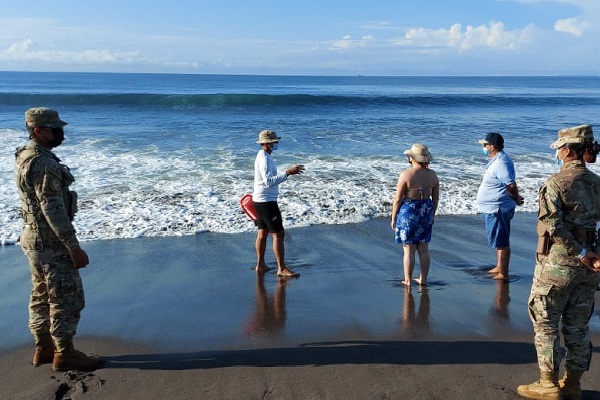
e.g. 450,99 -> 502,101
103,341 -> 536,370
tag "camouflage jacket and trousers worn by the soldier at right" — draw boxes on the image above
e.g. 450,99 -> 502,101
529,133 -> 600,373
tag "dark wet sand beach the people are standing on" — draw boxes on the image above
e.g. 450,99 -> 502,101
0,213 -> 600,400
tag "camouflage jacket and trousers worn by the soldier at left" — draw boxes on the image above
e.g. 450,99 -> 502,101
15,111 -> 85,352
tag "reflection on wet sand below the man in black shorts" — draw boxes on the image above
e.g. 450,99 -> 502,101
246,272 -> 288,337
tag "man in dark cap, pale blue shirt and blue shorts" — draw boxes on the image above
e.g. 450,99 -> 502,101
477,132 -> 523,282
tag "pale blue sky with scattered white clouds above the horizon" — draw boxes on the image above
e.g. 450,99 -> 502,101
0,0 -> 600,75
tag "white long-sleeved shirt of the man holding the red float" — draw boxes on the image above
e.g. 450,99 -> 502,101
252,149 -> 288,203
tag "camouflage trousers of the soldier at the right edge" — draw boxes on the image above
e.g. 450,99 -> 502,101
529,255 -> 600,372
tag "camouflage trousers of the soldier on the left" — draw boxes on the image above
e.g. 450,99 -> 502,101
21,229 -> 85,351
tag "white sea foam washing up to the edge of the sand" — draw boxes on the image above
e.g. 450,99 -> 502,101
0,126 -> 599,245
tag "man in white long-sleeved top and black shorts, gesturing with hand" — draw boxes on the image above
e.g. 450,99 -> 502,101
252,130 -> 304,277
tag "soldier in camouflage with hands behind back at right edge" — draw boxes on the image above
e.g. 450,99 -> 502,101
517,125 -> 600,400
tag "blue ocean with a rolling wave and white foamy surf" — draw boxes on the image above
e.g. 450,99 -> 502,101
0,72 -> 600,245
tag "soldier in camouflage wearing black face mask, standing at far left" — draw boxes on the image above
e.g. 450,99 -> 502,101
15,107 -> 101,371
